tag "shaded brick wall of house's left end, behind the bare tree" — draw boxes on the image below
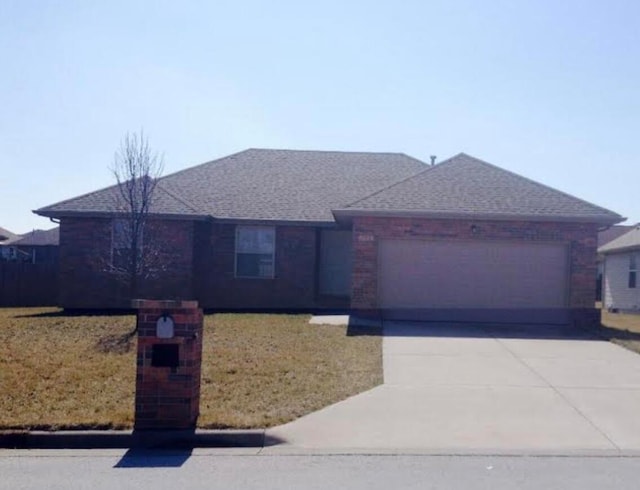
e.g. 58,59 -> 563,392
59,218 -> 194,308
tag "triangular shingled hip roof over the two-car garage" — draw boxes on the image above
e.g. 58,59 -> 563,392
335,153 -> 624,224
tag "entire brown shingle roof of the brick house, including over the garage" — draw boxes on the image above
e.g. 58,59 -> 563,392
35,149 -> 623,224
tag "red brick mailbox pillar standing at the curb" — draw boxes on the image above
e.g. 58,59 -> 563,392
132,300 -> 202,430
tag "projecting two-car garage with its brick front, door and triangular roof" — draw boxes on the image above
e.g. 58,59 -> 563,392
333,153 -> 623,331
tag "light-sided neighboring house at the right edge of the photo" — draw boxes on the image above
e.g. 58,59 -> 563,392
598,226 -> 640,311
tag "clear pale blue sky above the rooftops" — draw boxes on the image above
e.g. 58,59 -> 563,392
0,0 -> 640,233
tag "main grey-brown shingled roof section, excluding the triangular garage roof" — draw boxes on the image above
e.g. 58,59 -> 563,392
35,149 -> 425,222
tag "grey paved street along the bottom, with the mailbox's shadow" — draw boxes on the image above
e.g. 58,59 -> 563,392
0,449 -> 640,490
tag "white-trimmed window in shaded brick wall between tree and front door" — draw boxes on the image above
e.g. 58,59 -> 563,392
236,226 -> 276,279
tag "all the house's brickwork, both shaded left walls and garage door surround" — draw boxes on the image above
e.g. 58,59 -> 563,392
60,217 -> 597,321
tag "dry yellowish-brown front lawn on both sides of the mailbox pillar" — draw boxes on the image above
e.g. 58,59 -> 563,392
0,308 -> 382,429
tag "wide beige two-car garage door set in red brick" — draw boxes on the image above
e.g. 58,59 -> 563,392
378,240 -> 567,309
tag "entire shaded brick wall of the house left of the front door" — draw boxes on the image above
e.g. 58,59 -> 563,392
60,218 -> 318,310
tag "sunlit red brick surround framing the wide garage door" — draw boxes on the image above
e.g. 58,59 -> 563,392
351,217 -> 597,320
